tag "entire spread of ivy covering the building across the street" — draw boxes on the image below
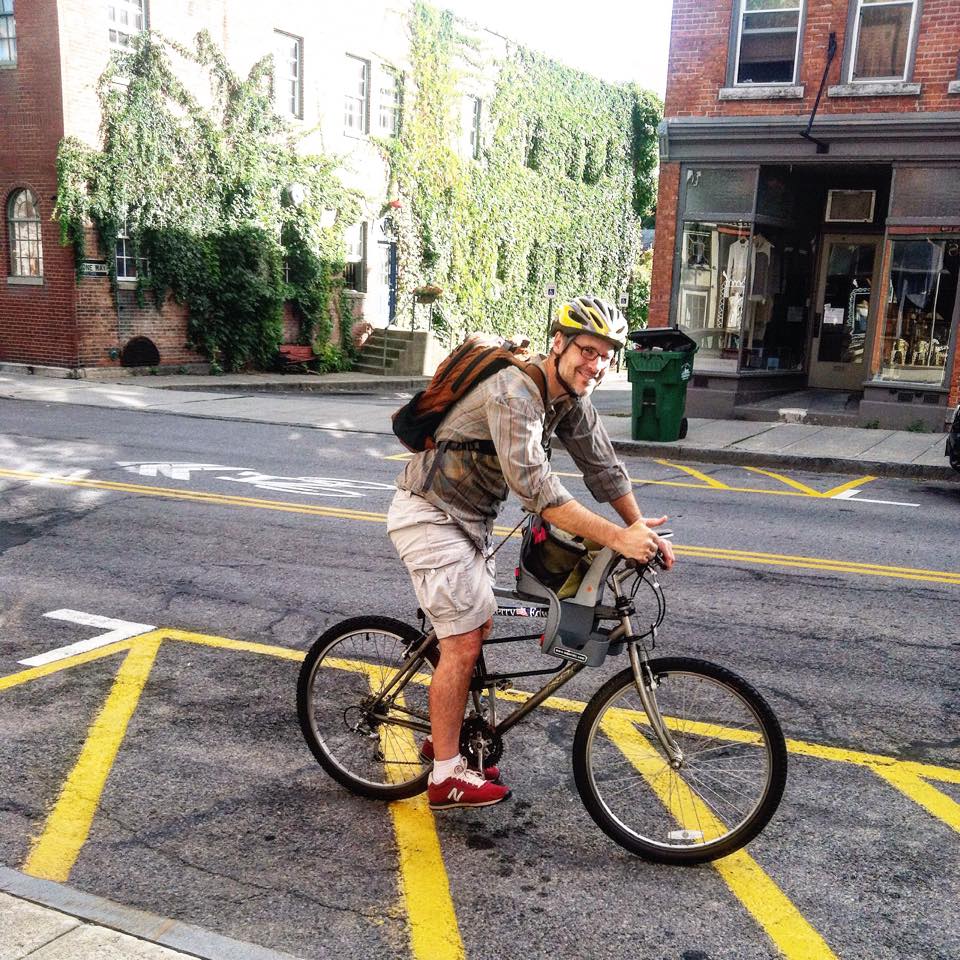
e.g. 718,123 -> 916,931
56,0 -> 661,369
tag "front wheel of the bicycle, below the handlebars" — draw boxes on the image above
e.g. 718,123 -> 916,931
573,657 -> 787,864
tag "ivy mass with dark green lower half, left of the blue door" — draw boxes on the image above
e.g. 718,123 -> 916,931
56,34 -> 358,370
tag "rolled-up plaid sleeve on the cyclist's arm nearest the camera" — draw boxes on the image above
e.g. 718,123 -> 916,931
486,393 -> 573,514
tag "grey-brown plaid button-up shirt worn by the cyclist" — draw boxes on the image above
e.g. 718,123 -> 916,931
397,360 -> 631,552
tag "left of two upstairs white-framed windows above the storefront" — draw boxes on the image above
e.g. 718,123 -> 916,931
734,0 -> 803,84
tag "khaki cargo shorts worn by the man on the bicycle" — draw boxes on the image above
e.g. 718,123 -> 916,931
387,490 -> 497,637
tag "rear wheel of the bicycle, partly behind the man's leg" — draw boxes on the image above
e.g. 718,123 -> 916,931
297,616 -> 432,800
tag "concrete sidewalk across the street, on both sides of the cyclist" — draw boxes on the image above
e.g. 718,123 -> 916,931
0,365 -> 960,480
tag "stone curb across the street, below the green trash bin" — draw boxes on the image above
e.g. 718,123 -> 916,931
613,440 -> 960,482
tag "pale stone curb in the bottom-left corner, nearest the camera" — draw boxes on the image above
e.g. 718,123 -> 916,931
0,866 -> 297,960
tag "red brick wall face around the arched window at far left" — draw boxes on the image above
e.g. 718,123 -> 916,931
0,0 -> 77,366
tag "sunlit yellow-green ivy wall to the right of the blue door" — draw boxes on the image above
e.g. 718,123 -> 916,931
384,2 -> 662,336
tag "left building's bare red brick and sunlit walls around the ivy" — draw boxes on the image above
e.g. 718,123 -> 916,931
0,0 -> 504,371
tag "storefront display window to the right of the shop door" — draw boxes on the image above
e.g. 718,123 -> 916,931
876,239 -> 960,386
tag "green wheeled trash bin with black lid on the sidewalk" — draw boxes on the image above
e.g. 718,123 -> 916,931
626,327 -> 697,441
